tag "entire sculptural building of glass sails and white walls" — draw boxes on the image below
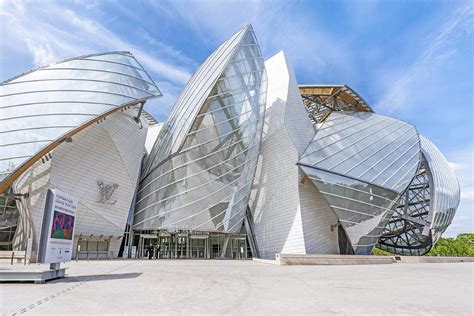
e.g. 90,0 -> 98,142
0,26 -> 460,259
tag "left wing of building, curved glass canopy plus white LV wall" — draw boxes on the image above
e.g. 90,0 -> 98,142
0,52 -> 161,260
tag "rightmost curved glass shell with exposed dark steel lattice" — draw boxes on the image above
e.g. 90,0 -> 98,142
378,135 -> 460,255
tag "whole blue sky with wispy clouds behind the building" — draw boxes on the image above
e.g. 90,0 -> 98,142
0,0 -> 474,236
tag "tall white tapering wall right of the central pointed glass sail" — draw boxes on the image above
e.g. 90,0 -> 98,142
249,52 -> 339,259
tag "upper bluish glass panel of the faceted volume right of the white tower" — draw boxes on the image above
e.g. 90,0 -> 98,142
299,111 -> 420,193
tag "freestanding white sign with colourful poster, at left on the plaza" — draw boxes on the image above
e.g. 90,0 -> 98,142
38,189 -> 78,263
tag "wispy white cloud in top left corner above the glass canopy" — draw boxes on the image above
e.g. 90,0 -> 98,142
2,2 -> 191,85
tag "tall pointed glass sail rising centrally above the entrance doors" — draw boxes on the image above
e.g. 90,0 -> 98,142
133,26 -> 266,233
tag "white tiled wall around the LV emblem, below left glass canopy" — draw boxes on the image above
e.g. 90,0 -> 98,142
14,109 -> 147,255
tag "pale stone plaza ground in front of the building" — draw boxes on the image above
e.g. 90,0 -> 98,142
0,260 -> 474,315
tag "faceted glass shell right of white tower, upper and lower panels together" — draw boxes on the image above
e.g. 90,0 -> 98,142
298,111 -> 420,254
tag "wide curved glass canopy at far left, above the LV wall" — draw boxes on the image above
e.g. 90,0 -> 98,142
0,52 -> 161,181
